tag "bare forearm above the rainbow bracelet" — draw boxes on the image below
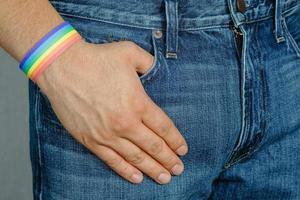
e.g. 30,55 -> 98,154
0,0 -> 63,61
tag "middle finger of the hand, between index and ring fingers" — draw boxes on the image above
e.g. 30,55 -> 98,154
125,123 -> 184,175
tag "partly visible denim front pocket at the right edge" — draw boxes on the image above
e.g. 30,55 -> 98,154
282,8 -> 300,57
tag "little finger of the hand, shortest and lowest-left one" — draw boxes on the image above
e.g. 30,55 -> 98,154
91,145 -> 143,183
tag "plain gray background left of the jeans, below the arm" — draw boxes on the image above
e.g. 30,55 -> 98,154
0,48 -> 32,200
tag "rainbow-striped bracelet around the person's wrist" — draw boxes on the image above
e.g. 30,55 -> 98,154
20,22 -> 81,82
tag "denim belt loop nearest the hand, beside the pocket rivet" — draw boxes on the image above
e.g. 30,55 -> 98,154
165,0 -> 178,59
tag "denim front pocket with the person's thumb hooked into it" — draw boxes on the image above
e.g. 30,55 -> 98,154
59,12 -> 163,84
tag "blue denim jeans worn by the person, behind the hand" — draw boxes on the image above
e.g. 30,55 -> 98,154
29,0 -> 300,200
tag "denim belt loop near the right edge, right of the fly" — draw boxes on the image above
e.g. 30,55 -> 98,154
273,0 -> 285,43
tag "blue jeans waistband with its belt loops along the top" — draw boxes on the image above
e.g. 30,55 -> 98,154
50,0 -> 300,59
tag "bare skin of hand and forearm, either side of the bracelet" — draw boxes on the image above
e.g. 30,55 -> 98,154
0,0 -> 188,184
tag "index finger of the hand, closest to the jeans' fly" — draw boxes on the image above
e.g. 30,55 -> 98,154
142,97 -> 188,155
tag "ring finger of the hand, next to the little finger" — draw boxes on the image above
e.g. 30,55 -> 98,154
112,138 -> 171,184
